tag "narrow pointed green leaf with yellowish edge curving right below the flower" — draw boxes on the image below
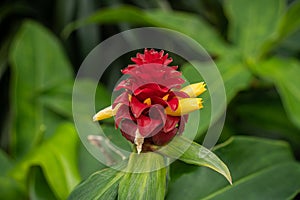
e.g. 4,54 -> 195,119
159,136 -> 231,184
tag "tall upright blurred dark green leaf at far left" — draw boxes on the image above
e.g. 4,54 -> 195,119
9,21 -> 73,158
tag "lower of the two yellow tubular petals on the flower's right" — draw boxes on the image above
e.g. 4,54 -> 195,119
165,98 -> 203,116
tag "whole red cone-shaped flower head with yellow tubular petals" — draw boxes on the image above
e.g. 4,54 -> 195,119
94,49 -> 206,153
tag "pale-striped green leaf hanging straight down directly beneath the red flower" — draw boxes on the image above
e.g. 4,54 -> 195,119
118,153 -> 167,200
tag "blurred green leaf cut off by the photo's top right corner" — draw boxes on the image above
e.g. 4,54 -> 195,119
279,1 -> 300,38
